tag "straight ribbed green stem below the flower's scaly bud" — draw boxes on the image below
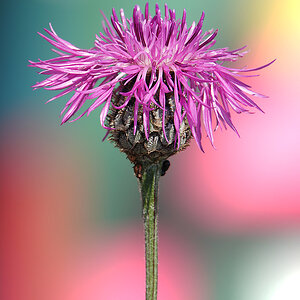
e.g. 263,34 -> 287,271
139,164 -> 161,300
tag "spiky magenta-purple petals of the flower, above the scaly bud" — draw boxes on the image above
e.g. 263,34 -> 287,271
30,3 -> 269,149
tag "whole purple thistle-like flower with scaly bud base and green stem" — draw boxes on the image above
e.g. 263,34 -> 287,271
30,4 -> 272,300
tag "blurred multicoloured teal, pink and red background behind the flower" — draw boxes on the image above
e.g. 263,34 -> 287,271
0,0 -> 300,300
